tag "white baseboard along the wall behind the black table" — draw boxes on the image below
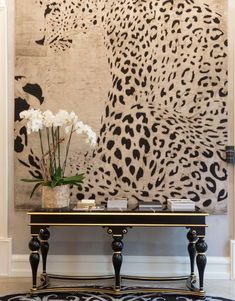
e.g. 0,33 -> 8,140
11,255 -> 230,279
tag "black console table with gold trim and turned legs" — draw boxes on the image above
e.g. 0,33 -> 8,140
28,210 -> 208,296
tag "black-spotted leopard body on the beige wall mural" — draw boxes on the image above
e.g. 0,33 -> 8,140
15,0 -> 227,211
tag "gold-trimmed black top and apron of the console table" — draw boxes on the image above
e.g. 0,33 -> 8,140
28,208 -> 208,236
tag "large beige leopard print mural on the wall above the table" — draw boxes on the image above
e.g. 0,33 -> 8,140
15,0 -> 228,213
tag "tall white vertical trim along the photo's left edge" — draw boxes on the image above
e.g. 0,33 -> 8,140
0,0 -> 11,275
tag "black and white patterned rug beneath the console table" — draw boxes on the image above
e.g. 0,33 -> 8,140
0,293 -> 234,301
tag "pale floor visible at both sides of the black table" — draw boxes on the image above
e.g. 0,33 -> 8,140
0,277 -> 235,300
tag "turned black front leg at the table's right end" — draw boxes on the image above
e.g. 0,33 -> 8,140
196,237 -> 207,292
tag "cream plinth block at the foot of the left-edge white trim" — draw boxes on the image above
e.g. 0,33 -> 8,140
0,237 -> 12,276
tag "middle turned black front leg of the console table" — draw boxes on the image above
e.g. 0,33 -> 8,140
108,227 -> 127,291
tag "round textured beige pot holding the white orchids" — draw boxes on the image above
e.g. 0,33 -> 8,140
42,185 -> 70,208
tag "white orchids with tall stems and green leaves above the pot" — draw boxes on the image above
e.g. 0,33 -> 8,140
20,109 -> 96,198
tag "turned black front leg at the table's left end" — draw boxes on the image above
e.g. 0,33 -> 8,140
29,236 -> 40,290
